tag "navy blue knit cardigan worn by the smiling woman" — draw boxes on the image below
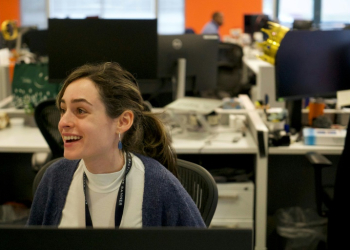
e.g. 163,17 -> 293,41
27,155 -> 206,227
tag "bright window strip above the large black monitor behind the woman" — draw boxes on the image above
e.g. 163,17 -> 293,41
21,0 -> 185,34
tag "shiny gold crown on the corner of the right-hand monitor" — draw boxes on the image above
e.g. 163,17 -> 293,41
258,22 -> 289,65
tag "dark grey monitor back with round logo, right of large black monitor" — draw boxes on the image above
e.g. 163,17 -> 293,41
158,34 -> 219,91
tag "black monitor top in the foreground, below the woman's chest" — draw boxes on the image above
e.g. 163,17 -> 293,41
0,227 -> 253,250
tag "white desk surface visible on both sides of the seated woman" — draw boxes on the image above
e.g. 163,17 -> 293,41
0,126 -> 257,154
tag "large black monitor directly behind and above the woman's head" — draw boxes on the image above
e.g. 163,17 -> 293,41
48,19 -> 158,82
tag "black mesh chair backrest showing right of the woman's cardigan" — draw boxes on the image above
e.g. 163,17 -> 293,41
177,159 -> 218,227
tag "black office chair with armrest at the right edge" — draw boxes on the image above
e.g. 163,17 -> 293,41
306,116 -> 350,249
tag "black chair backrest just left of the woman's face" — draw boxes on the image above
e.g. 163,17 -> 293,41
34,99 -> 64,159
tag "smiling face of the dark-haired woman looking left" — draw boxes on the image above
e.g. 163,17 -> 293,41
58,78 -> 119,161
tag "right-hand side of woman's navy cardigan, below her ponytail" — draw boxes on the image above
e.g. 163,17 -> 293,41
139,153 -> 206,227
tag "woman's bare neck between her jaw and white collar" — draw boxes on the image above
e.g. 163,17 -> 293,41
84,150 -> 125,174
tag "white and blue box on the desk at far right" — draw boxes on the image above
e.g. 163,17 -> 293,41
303,128 -> 346,146
